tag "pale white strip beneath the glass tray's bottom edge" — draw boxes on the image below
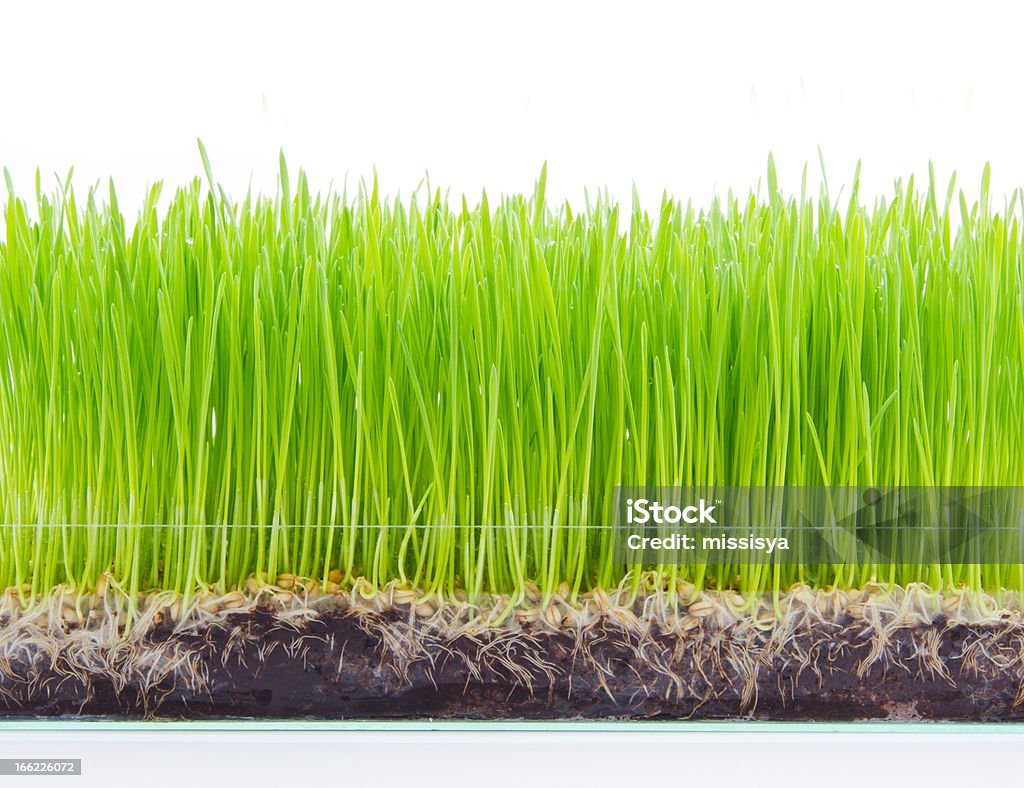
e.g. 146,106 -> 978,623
6,731 -> 1022,788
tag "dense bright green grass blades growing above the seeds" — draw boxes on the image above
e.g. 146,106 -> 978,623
0,155 -> 1024,600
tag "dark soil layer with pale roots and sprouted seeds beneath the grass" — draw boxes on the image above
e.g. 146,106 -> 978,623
0,577 -> 1024,720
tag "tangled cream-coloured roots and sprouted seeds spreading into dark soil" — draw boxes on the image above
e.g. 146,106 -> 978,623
0,580 -> 1024,716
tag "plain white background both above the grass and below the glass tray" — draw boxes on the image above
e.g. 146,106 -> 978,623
0,0 -> 1024,786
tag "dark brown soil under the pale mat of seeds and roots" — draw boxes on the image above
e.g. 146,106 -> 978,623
0,612 -> 1024,720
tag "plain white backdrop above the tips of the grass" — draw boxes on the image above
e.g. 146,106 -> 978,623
6,0 -> 1024,208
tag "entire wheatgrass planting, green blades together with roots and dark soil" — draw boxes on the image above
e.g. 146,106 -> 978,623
0,155 -> 1024,720
